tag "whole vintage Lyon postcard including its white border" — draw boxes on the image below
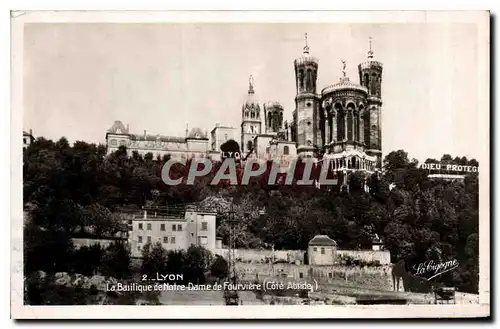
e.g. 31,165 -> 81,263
11,11 -> 490,319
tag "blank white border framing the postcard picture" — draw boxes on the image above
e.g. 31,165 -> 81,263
11,11 -> 490,319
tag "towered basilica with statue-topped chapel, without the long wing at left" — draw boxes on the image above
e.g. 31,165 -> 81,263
241,35 -> 383,173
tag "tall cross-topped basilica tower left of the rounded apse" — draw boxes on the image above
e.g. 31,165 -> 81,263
294,34 -> 322,157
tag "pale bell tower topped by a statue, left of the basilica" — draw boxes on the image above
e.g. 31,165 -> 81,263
240,76 -> 262,155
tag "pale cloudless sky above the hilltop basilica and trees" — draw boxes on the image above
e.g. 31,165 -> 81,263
23,22 -> 484,161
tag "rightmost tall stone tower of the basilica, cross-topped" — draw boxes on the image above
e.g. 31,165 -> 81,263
358,38 -> 383,168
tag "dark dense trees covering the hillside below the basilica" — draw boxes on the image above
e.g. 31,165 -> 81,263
24,138 -> 479,292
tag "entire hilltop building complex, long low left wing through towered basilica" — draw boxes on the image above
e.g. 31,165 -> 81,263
106,34 -> 383,177
